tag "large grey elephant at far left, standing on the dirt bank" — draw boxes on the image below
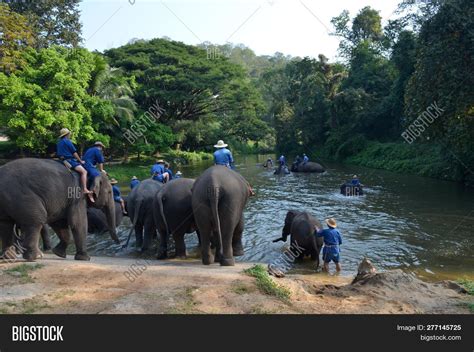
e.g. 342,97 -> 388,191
0,158 -> 119,261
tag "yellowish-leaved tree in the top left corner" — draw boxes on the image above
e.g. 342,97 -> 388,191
0,3 -> 34,73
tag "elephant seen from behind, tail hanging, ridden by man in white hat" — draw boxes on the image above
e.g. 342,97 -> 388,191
192,165 -> 253,266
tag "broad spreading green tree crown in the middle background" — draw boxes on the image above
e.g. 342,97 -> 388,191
106,39 -> 268,150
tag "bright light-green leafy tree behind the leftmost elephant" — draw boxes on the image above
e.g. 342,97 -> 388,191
0,47 -> 113,153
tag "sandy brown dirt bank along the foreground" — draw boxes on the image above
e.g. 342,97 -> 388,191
0,255 -> 469,314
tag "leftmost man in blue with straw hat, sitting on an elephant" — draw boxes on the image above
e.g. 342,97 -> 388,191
56,128 -> 94,203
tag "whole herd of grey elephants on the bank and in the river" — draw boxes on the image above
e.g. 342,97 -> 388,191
0,158 -> 358,266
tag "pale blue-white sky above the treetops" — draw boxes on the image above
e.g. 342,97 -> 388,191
80,0 -> 401,60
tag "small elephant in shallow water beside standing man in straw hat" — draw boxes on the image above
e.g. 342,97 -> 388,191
273,210 -> 323,268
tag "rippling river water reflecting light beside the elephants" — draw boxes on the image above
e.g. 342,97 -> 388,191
89,155 -> 474,280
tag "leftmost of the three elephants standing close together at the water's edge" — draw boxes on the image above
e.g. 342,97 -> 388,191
127,179 -> 163,252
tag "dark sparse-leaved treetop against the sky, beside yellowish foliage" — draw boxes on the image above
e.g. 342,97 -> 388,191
9,0 -> 82,48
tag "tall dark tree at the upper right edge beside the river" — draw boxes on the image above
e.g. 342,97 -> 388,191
405,0 -> 474,180
